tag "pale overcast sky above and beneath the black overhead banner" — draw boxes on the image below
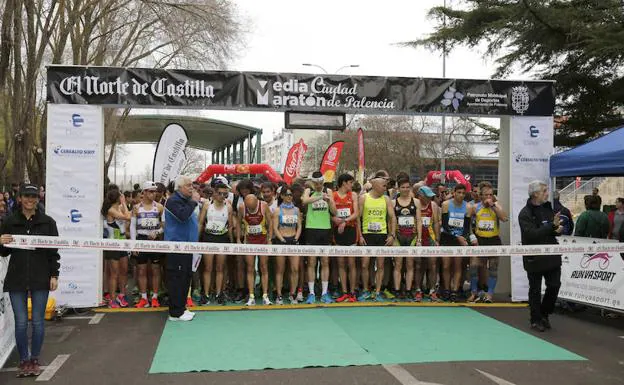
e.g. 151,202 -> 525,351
118,0 -> 521,180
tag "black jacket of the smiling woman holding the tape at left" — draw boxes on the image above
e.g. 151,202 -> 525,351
0,210 -> 61,292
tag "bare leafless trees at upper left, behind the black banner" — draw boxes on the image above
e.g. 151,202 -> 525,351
0,0 -> 242,183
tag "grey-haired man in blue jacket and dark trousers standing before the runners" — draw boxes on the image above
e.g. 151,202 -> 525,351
165,176 -> 199,321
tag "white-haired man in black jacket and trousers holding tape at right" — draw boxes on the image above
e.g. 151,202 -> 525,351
518,180 -> 563,332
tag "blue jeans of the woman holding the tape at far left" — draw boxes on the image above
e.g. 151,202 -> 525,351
9,290 -> 50,361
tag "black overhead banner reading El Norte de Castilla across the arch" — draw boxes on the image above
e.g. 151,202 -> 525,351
47,66 -> 555,116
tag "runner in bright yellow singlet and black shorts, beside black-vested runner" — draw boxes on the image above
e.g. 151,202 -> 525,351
358,172 -> 396,301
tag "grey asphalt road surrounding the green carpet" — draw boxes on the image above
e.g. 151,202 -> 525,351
0,308 -> 624,385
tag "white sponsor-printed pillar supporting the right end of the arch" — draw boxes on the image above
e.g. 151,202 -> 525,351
509,116 -> 554,301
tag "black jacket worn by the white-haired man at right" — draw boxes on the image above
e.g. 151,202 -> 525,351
518,199 -> 561,273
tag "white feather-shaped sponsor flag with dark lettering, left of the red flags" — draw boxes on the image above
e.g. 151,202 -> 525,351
152,123 -> 188,186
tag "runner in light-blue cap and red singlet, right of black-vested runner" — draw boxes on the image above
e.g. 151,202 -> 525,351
414,186 -> 441,302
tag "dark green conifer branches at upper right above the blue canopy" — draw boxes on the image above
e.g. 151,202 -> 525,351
404,0 -> 624,146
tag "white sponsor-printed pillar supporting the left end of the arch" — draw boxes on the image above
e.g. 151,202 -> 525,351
46,104 -> 104,307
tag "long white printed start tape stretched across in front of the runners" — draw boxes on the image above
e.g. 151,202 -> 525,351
5,235 -> 624,258
